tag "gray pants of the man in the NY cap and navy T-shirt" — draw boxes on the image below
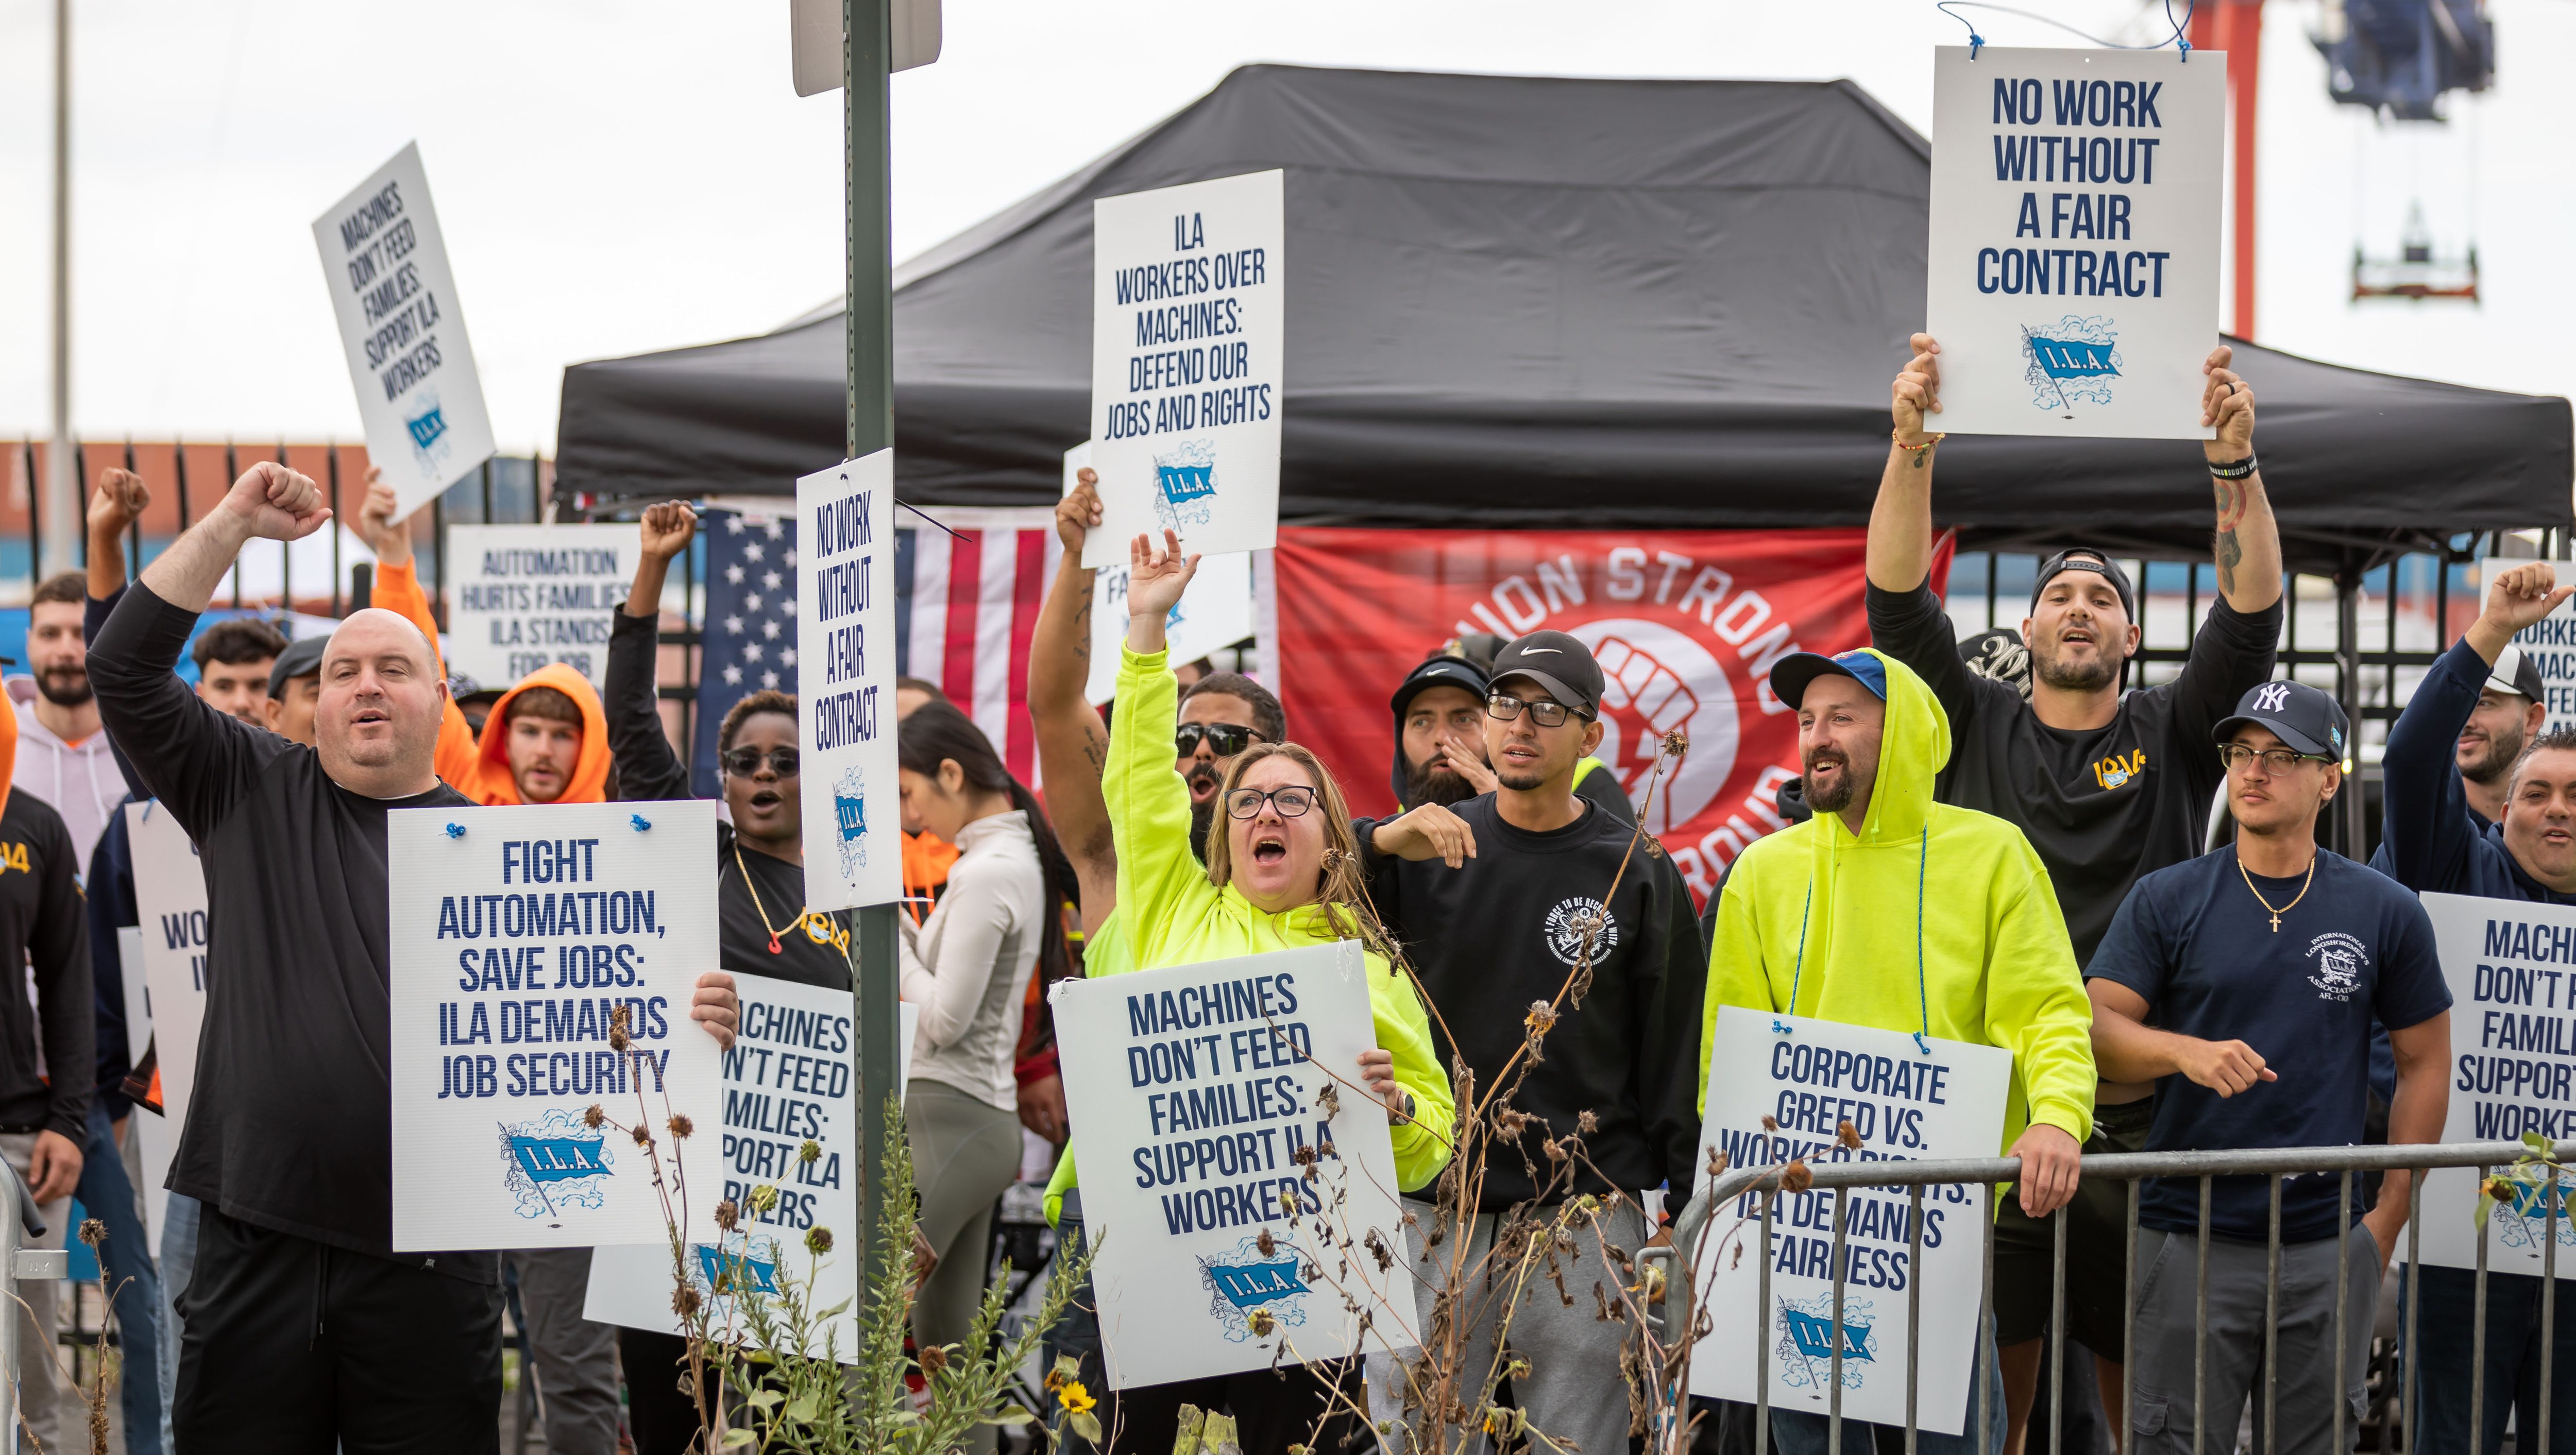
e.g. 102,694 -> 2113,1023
2130,1226 -> 2380,1455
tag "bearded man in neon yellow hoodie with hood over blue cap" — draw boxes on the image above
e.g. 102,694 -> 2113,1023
1700,649 -> 2094,1455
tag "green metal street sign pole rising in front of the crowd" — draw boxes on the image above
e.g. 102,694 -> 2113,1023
840,0 -> 902,1288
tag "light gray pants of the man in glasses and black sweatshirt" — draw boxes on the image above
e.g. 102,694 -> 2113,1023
1368,1197 -> 1646,1450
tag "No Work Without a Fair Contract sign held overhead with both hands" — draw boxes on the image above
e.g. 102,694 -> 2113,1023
1924,46 -> 2228,440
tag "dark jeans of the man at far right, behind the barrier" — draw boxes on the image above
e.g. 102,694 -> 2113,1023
2398,1267 -> 2576,1455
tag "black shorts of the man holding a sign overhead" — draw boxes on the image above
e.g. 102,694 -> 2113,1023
1994,1097 -> 2156,1362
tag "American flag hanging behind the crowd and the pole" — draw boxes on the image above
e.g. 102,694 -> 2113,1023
690,507 -> 1064,796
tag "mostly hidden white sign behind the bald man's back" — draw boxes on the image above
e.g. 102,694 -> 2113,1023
126,801 -> 206,1257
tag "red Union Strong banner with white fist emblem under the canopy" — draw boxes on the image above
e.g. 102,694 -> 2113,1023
1275,528 -> 1950,899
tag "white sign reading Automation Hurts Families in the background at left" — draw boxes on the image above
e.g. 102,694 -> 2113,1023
448,525 -> 636,688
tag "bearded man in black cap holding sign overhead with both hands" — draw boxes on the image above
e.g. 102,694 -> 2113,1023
1868,335 -> 2282,1450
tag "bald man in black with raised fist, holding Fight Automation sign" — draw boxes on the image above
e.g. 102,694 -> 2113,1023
90,461 -> 737,1455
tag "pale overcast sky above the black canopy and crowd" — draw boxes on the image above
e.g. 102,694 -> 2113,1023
0,0 -> 2576,453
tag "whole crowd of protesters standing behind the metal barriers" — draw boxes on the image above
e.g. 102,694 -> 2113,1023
0,323 -> 2576,1455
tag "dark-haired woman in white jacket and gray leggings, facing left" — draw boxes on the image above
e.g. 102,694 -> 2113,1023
899,703 -> 1066,1391
